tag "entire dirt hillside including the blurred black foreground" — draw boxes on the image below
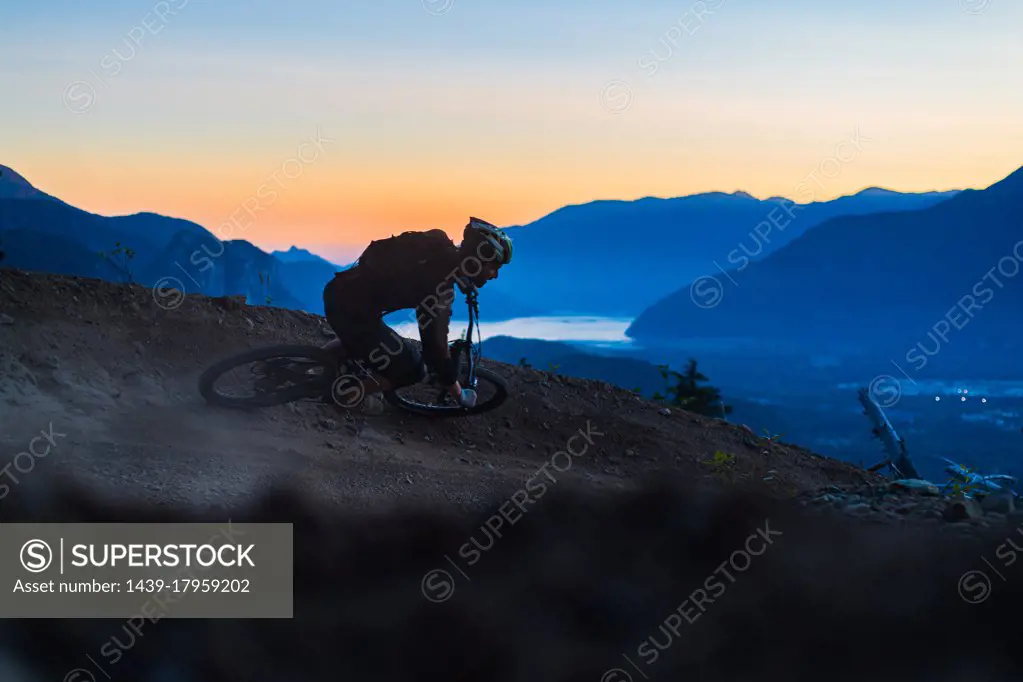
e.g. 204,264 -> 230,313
0,271 -> 1023,682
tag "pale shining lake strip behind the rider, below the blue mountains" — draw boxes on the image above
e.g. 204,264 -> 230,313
394,316 -> 632,348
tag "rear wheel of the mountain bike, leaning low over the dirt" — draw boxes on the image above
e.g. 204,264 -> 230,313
198,346 -> 337,409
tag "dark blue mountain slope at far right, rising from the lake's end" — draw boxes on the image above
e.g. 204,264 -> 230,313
627,169 -> 1023,357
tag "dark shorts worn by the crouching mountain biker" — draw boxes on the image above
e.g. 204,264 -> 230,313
323,280 -> 427,389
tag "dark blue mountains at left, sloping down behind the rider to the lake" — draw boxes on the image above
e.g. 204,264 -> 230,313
0,166 -> 538,321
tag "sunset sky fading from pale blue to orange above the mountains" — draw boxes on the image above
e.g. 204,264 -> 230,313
0,0 -> 1023,261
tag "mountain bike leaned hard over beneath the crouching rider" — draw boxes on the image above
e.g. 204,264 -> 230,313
198,289 -> 508,417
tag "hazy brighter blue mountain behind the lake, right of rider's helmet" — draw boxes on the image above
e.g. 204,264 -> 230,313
491,187 -> 957,317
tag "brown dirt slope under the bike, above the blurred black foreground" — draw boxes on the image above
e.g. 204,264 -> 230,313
0,270 -> 878,508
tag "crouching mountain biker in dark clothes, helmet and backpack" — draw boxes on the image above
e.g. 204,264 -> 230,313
323,218 -> 512,409
